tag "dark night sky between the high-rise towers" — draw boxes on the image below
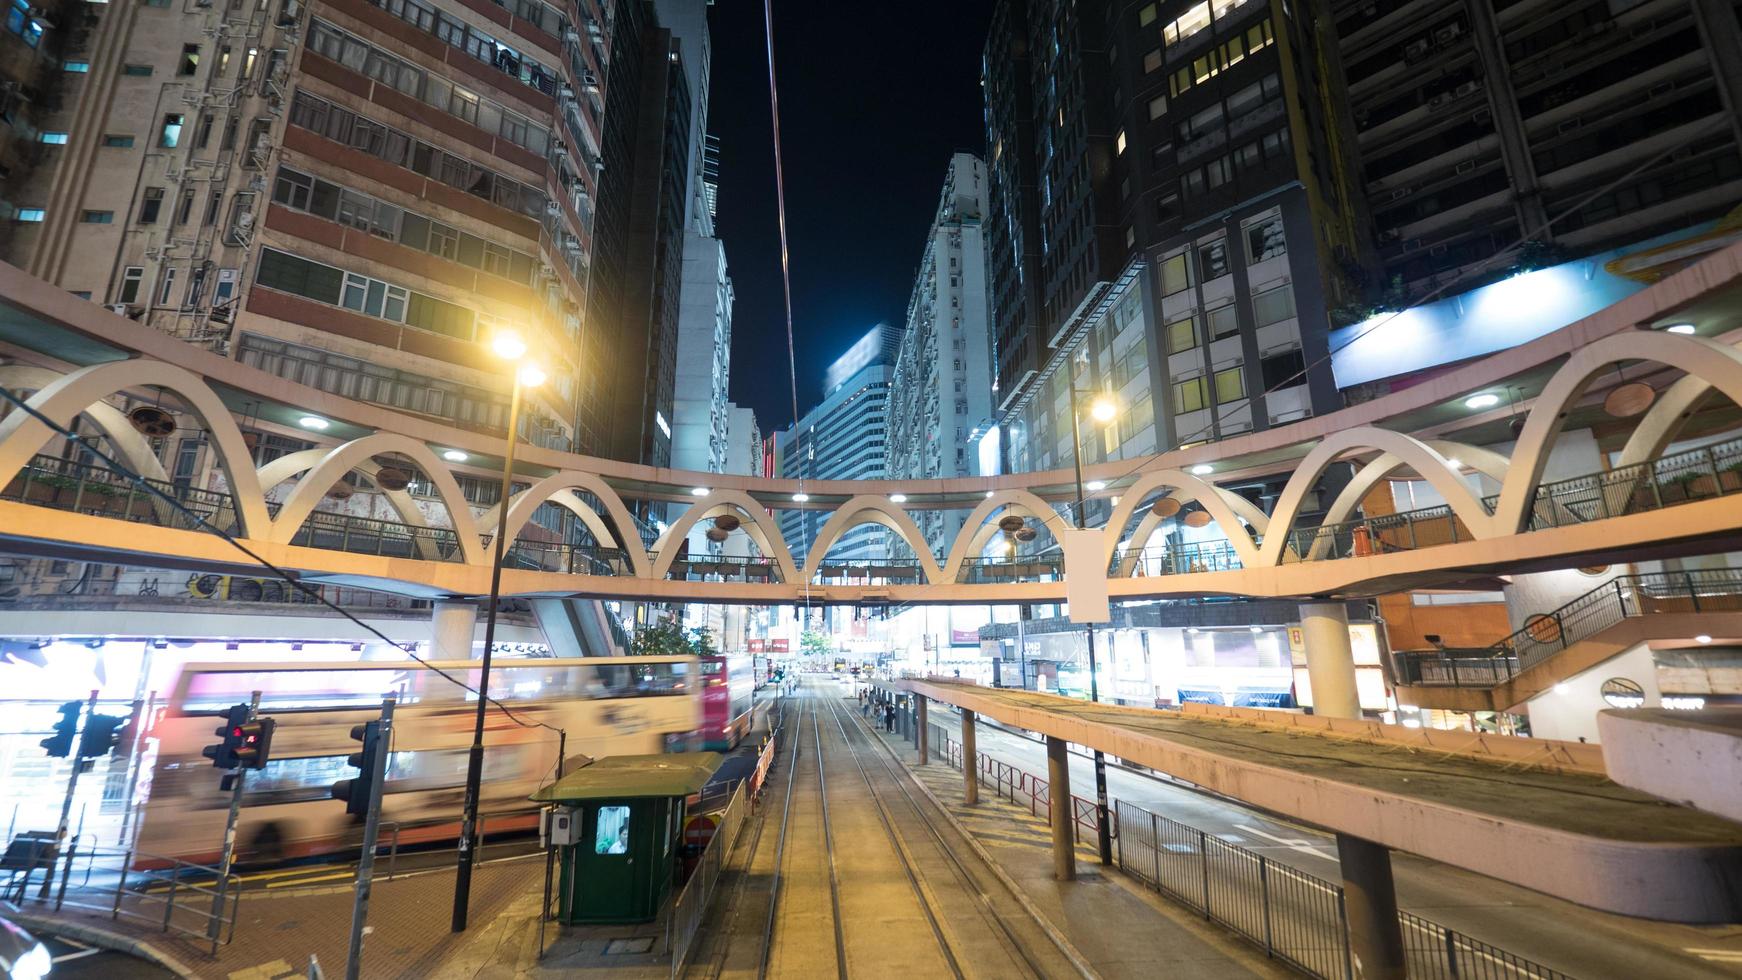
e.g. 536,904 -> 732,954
709,0 -> 991,433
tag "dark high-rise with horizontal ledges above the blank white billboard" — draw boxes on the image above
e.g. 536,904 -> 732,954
1331,0 -> 1742,308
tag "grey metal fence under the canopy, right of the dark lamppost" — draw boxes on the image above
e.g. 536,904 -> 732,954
1115,801 -> 1570,980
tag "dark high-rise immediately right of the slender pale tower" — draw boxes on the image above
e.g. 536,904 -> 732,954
981,0 -> 1157,470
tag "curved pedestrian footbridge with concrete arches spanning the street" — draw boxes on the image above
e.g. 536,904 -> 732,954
0,247 -> 1742,604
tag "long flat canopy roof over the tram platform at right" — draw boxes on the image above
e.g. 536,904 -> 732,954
887,679 -> 1742,923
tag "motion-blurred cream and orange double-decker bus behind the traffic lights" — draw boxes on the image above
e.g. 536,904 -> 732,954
136,656 -> 702,867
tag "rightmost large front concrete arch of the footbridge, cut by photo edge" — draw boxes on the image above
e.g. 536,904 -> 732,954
1472,331 -> 1742,534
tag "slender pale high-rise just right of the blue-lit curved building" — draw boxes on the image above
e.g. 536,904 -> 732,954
885,153 -> 993,547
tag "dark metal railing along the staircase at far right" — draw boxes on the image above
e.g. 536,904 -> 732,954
1395,567 -> 1742,688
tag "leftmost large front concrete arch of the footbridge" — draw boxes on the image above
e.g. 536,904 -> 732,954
0,359 -> 272,538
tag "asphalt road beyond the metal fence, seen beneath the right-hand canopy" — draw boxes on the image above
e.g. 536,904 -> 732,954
932,710 -> 1742,980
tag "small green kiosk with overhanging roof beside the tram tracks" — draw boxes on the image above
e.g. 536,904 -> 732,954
533,752 -> 725,926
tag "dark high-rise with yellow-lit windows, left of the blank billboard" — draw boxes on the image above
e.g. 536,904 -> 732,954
1106,0 -> 1371,449
